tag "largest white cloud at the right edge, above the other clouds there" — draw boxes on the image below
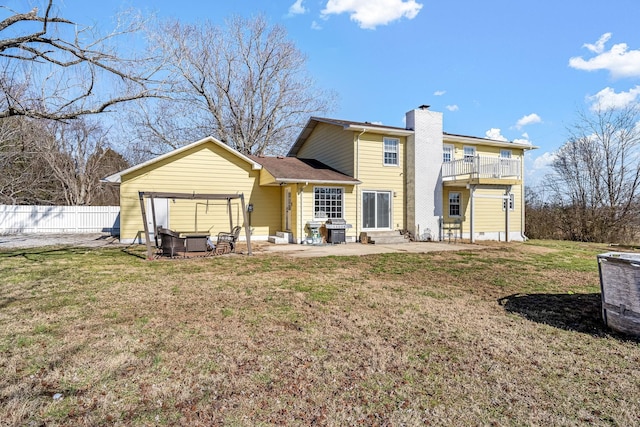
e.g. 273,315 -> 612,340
569,33 -> 640,77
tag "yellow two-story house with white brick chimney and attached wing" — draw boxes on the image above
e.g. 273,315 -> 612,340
104,106 -> 533,243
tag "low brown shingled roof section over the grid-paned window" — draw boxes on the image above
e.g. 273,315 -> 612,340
248,156 -> 360,185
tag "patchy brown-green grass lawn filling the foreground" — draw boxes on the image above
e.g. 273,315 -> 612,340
0,241 -> 640,426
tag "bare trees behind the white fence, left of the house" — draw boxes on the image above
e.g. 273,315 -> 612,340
0,117 -> 128,205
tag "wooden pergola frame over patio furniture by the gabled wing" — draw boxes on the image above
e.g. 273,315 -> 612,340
138,191 -> 251,259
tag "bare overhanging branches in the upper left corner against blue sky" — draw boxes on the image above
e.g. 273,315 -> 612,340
0,0 -> 164,120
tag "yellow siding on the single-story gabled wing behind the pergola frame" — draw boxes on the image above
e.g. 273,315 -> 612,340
120,143 -> 281,239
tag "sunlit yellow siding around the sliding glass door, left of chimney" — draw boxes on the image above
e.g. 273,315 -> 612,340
354,133 -> 406,230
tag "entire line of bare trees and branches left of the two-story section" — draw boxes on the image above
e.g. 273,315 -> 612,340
0,0 -> 332,205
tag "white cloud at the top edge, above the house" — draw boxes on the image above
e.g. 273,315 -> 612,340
321,0 -> 422,30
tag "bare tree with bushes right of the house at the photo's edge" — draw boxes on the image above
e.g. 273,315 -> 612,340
549,105 -> 640,241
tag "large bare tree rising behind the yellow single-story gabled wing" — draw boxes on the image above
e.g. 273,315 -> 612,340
128,17 -> 332,158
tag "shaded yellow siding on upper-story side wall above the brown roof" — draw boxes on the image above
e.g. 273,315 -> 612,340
296,123 -> 355,176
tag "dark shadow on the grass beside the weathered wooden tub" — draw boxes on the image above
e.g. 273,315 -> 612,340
498,293 -> 611,336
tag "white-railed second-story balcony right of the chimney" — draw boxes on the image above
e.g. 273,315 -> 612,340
442,155 -> 522,185
